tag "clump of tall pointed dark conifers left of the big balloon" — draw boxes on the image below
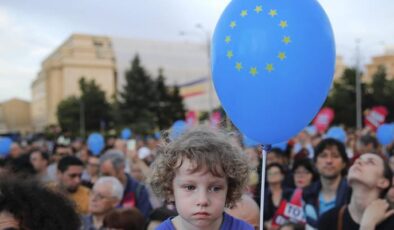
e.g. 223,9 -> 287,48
117,55 -> 185,134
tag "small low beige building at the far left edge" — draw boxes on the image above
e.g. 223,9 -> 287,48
0,98 -> 33,134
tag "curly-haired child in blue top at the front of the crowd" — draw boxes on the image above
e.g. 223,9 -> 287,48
150,127 -> 253,230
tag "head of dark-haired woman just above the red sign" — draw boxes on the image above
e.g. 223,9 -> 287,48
292,158 -> 318,189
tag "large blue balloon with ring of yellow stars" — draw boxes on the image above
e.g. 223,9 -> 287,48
211,0 -> 335,144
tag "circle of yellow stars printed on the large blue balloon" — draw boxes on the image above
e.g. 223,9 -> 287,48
224,5 -> 292,77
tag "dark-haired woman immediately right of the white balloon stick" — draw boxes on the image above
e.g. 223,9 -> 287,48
264,163 -> 293,228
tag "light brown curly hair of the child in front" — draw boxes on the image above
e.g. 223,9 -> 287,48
150,127 -> 250,208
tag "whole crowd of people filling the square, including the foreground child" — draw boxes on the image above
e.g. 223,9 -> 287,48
0,127 -> 394,230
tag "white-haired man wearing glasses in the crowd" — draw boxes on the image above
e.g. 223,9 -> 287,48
82,176 -> 123,230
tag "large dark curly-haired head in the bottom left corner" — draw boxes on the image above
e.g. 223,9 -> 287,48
0,177 -> 80,230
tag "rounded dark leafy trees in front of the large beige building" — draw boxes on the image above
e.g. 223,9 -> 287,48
57,77 -> 111,134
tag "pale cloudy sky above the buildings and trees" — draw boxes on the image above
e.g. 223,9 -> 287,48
0,0 -> 394,102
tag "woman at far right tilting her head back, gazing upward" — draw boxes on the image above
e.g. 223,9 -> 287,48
318,153 -> 394,230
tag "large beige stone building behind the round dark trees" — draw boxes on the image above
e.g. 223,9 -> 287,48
31,34 -> 116,131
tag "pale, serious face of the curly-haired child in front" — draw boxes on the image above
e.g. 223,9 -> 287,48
172,159 -> 227,229
